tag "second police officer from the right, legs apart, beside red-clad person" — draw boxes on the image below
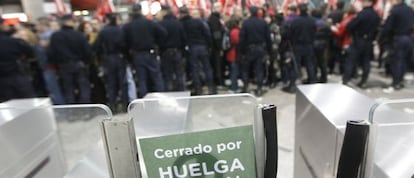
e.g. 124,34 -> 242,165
342,0 -> 381,88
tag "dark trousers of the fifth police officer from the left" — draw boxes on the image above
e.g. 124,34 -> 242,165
161,49 -> 185,91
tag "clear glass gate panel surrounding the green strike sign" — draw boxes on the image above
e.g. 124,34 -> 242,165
128,93 -> 264,178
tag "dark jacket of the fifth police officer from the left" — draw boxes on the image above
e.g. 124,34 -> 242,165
160,15 -> 187,51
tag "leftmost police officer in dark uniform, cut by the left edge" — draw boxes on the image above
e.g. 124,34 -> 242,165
0,17 -> 35,102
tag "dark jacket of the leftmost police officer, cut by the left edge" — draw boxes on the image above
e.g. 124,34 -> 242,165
0,34 -> 34,77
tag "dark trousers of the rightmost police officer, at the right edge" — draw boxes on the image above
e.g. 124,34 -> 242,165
390,36 -> 414,85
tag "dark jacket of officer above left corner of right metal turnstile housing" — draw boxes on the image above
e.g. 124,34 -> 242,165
290,14 -> 317,45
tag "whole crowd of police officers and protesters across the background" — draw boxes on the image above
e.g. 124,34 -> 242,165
0,0 -> 414,109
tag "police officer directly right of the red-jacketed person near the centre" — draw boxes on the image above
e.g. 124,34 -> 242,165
239,6 -> 272,96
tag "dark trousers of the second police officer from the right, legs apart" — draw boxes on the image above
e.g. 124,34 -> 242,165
342,40 -> 373,84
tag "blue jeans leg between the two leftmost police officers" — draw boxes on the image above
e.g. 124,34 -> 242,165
43,69 -> 65,105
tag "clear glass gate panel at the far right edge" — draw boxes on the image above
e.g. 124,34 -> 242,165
365,99 -> 414,177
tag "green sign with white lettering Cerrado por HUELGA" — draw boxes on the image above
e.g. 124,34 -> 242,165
139,126 -> 256,178
